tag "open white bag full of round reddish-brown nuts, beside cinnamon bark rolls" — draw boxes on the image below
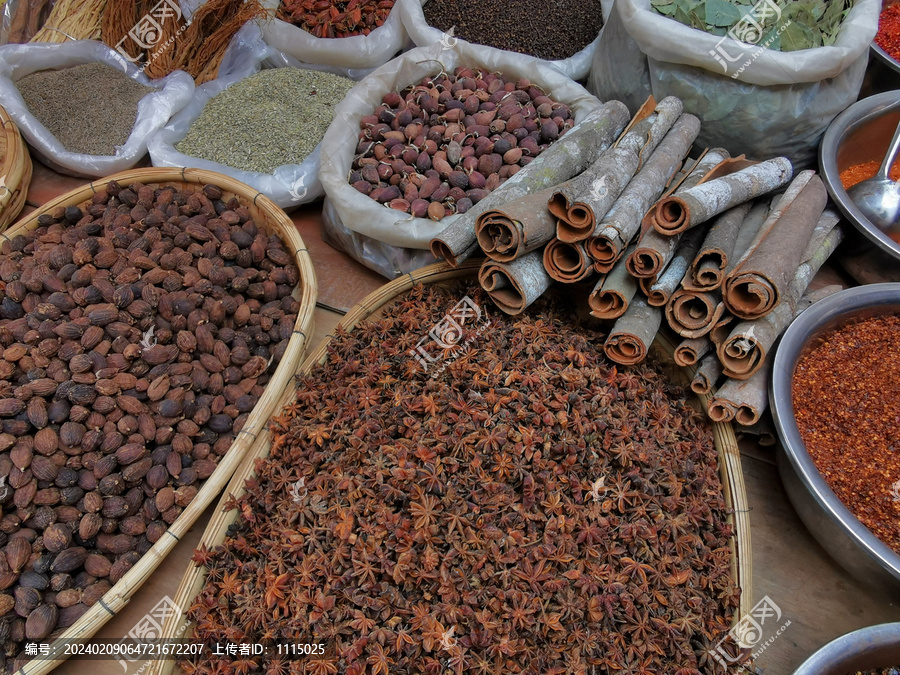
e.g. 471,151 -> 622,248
319,41 -> 600,278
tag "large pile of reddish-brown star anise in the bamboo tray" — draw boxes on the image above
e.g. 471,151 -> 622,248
181,285 -> 740,675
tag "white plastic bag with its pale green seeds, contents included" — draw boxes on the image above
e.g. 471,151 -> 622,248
149,23 -> 354,209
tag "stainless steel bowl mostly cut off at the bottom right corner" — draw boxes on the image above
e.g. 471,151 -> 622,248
794,623 -> 900,675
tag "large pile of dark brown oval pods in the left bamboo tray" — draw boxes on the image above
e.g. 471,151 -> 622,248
0,182 -> 299,666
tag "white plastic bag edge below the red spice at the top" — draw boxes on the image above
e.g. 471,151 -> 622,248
258,0 -> 406,80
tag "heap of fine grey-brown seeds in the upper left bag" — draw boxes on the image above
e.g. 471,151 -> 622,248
15,63 -> 153,155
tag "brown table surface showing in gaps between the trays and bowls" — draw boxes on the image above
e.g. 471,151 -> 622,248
14,149 -> 900,675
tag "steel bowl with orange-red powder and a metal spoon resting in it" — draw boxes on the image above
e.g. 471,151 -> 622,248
819,90 -> 900,258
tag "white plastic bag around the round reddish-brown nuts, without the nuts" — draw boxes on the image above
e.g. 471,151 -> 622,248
319,42 -> 600,277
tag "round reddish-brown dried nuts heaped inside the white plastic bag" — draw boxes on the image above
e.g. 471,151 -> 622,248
349,67 -> 575,220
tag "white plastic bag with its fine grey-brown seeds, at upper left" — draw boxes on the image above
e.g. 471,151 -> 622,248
0,40 -> 194,178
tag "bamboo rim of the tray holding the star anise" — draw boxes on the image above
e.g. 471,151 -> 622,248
155,260 -> 753,675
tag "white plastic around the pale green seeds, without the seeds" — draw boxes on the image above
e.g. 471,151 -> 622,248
149,23 -> 340,208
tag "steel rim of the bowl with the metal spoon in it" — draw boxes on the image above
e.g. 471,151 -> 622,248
819,89 -> 900,258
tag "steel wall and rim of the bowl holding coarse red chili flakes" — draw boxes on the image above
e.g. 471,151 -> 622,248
769,283 -> 900,581
